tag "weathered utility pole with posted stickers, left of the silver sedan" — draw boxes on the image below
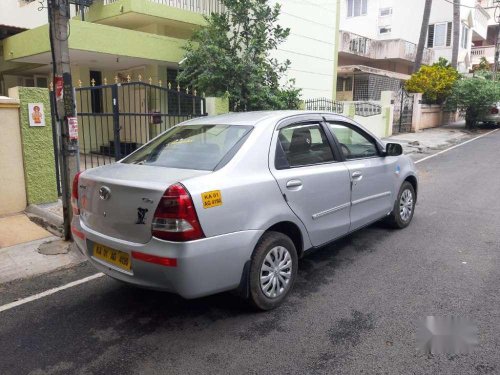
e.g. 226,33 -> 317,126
47,0 -> 80,240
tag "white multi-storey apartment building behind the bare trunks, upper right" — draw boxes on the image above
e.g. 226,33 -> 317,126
337,0 -> 491,99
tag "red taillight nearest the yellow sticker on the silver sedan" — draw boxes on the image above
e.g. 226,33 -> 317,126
152,184 -> 205,242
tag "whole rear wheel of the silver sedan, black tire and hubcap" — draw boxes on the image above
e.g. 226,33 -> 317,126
248,232 -> 298,310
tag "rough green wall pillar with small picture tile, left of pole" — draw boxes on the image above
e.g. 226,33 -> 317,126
9,87 -> 57,204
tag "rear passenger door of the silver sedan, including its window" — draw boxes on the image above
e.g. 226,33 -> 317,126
270,122 -> 350,246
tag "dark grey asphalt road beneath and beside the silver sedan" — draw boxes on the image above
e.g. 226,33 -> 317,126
0,131 -> 500,375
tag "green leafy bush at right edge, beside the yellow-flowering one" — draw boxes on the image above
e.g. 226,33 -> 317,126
446,78 -> 500,129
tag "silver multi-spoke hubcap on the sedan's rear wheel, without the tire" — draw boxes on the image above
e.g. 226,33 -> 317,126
260,246 -> 292,298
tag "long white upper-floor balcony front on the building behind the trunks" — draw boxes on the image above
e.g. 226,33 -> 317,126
339,31 -> 434,65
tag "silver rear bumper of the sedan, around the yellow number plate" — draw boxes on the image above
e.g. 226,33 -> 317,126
73,218 -> 263,298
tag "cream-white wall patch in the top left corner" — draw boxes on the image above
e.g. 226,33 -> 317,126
0,0 -> 47,29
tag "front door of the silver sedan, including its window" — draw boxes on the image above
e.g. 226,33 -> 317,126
328,121 -> 397,231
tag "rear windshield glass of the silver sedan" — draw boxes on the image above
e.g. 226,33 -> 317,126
122,125 -> 252,171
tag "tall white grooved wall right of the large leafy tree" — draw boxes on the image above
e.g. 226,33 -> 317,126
271,0 -> 337,99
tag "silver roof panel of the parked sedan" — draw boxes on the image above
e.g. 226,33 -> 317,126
179,111 -> 343,126
